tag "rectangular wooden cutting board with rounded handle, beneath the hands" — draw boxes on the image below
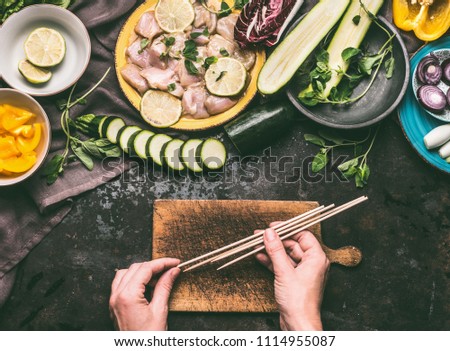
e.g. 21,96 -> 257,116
152,200 -> 362,312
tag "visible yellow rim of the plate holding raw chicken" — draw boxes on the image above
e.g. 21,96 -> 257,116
116,0 -> 266,131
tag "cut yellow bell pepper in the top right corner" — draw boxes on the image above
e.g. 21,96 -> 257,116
392,0 -> 450,41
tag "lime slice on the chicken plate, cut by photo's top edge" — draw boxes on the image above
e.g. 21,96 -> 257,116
155,0 -> 195,33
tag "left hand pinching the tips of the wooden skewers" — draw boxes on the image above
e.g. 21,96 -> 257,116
109,258 -> 180,330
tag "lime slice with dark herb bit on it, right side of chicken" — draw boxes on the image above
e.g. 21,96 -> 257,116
205,57 -> 247,96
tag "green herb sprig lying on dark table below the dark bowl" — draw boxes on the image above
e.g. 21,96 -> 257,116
304,127 -> 379,188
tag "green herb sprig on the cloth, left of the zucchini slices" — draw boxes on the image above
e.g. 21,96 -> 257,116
42,68 -> 121,185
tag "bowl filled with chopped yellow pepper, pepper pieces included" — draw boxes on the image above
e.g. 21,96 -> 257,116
0,89 -> 51,186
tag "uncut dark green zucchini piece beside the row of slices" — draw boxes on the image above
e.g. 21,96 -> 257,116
225,100 -> 298,154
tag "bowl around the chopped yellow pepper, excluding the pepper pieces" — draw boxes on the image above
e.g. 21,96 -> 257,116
0,89 -> 52,186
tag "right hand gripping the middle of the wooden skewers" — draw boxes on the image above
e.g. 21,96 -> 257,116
256,227 -> 330,330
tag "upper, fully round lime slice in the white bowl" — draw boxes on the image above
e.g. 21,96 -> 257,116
24,28 -> 66,67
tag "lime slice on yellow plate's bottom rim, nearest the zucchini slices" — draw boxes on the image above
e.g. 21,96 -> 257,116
141,90 -> 182,128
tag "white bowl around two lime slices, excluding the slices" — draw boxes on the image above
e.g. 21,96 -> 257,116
0,5 -> 91,96
